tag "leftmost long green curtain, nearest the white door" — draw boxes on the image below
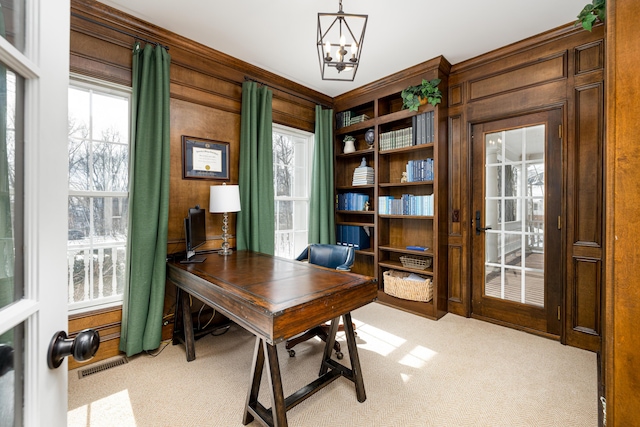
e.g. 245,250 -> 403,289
120,42 -> 171,356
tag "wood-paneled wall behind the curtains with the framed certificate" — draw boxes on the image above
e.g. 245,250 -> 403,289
69,0 -> 332,366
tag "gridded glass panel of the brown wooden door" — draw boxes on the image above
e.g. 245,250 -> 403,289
482,125 -> 545,306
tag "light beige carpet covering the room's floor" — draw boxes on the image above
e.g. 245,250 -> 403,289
68,303 -> 598,427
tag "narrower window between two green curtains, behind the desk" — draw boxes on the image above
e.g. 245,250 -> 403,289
273,124 -> 314,259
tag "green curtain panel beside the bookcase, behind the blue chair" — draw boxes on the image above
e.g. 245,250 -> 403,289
309,105 -> 336,244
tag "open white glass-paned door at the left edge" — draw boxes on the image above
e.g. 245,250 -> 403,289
0,0 -> 70,427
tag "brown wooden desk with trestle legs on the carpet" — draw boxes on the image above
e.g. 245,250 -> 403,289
167,251 -> 378,427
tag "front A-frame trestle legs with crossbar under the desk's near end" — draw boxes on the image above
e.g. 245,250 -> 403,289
242,313 -> 367,427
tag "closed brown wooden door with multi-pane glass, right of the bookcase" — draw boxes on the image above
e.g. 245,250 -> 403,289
471,109 -> 563,336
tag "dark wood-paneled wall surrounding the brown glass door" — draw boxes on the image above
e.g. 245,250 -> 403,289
448,21 -> 604,351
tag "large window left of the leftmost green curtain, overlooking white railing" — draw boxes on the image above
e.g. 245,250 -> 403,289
67,77 -> 131,312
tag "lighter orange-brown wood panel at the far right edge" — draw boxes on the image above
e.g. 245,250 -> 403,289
604,0 -> 640,427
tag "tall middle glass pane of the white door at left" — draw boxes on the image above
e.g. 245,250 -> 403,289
0,64 -> 24,308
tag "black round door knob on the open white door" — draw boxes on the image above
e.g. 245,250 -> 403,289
47,329 -> 100,369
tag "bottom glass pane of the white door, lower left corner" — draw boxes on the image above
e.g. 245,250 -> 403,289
0,323 -> 24,426
